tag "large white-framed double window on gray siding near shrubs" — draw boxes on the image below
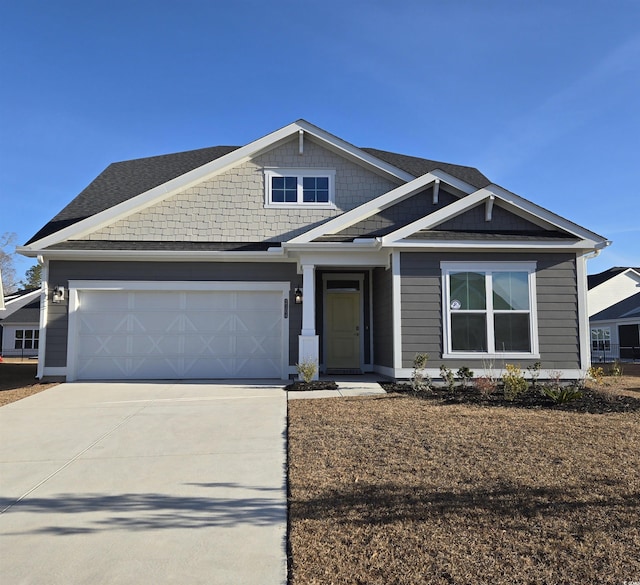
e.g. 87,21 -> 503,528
441,262 -> 538,357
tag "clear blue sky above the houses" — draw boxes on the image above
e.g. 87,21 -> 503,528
0,0 -> 640,277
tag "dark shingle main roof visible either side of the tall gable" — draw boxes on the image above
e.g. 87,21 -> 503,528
25,141 -> 490,245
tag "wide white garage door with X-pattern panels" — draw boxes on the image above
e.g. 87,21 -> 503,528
70,290 -> 286,380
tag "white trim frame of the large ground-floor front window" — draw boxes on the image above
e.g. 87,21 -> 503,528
440,262 -> 540,360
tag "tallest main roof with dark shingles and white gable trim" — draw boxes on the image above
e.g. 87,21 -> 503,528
24,120 -> 488,251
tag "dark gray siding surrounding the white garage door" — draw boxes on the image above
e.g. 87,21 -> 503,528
44,261 -> 302,367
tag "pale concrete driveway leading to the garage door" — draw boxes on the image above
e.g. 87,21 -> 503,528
0,382 -> 287,585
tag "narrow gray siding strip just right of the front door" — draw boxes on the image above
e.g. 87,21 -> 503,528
372,268 -> 393,368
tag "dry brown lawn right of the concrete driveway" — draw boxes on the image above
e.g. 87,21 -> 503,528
289,384 -> 640,585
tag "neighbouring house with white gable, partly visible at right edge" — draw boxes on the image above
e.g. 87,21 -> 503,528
587,266 -> 640,362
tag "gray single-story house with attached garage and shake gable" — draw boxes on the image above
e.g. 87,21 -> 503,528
18,120 -> 608,380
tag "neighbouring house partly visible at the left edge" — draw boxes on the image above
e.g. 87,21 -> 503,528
0,289 -> 40,357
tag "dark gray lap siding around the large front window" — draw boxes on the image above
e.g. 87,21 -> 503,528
400,252 -> 580,371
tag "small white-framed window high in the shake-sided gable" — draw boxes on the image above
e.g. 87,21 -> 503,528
264,169 -> 336,209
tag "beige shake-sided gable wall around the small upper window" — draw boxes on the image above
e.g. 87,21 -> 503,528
80,139 -> 398,242
